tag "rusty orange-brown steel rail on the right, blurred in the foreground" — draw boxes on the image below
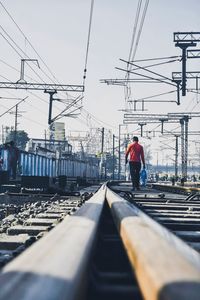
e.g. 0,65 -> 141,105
106,189 -> 200,300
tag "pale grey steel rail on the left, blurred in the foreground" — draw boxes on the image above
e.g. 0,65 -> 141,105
0,186 -> 106,300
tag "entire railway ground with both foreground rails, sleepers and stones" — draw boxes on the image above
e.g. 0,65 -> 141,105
0,181 -> 200,300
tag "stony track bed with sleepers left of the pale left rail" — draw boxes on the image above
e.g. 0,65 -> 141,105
0,190 -> 96,267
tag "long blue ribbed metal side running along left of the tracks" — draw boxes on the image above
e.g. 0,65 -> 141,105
0,149 -> 99,189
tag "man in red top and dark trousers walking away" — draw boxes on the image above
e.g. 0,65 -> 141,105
125,136 -> 145,190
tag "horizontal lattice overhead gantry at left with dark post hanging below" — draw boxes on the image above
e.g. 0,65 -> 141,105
0,80 -> 84,125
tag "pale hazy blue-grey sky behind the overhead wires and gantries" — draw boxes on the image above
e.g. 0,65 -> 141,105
0,0 -> 200,165
